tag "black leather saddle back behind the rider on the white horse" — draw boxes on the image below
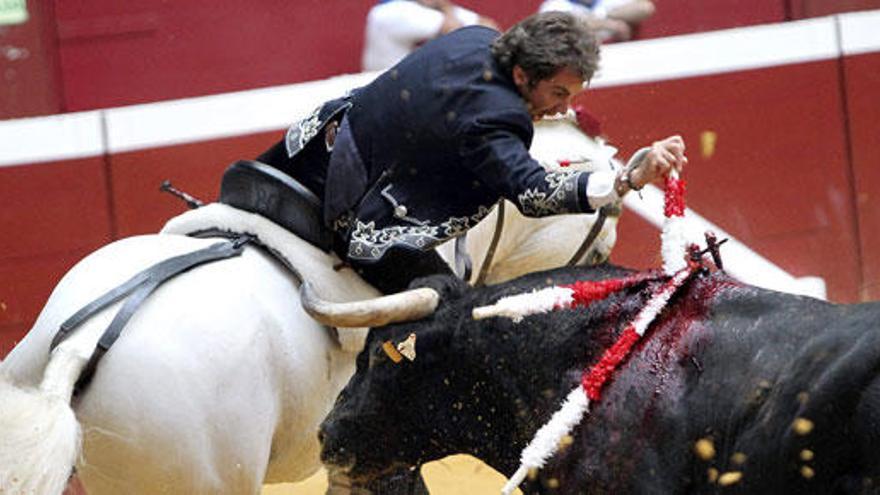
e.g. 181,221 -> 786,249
220,160 -> 333,251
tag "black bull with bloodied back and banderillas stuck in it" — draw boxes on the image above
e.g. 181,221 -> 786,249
321,266 -> 880,494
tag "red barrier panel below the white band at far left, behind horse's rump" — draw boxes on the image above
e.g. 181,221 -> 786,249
0,157 -> 112,356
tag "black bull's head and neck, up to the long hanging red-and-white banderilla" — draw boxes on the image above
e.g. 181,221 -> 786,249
320,267 -> 641,483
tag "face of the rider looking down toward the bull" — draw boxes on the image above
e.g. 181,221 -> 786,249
513,65 -> 584,121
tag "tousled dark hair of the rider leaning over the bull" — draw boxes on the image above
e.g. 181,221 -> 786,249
492,12 -> 599,85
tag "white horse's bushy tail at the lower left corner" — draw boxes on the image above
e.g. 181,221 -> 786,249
0,346 -> 86,495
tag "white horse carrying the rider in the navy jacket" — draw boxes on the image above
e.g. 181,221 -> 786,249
0,114 -> 613,495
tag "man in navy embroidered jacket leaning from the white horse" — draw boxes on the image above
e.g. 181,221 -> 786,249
259,12 -> 686,293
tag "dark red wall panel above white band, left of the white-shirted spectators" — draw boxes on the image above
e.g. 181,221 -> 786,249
51,0 -> 370,111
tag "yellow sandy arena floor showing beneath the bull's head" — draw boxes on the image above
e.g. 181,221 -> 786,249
262,455 -> 520,495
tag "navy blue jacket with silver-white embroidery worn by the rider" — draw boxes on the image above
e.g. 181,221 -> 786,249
287,26 -> 593,261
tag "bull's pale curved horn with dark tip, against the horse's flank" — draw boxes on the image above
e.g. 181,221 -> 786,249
299,282 -> 440,327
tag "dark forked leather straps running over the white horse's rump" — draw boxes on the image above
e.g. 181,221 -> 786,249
49,236 -> 251,395
